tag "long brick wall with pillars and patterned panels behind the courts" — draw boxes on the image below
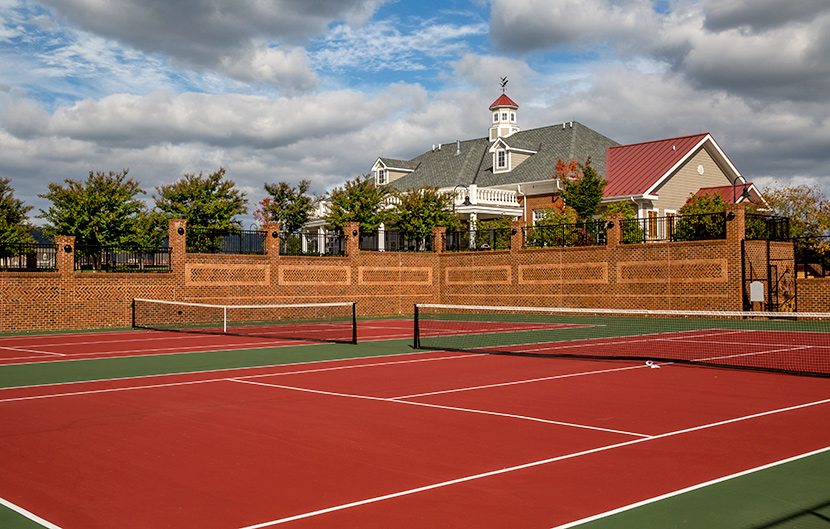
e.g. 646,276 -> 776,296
6,206 -> 830,332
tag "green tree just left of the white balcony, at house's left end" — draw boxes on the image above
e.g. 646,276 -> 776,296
325,174 -> 391,233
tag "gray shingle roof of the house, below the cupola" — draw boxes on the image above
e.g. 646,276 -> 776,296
383,121 -> 619,190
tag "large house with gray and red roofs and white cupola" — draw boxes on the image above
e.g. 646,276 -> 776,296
372,94 -> 760,229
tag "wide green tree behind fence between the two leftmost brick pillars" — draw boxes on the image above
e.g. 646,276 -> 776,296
38,169 -> 163,250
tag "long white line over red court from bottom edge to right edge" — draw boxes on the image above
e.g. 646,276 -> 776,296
232,399 -> 830,529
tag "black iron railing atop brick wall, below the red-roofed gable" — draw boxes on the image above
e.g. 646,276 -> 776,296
620,212 -> 726,244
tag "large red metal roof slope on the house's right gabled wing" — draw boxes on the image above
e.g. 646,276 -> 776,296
604,133 -> 709,197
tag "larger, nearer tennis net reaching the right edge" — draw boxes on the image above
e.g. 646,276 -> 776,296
414,304 -> 830,377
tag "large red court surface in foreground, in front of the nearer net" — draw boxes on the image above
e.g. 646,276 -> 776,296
0,346 -> 830,529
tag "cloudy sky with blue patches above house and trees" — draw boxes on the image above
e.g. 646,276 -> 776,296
0,0 -> 830,224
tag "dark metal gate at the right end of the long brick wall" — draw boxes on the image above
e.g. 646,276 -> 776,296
741,240 -> 798,312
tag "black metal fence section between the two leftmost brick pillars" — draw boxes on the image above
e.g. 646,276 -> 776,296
75,244 -> 172,272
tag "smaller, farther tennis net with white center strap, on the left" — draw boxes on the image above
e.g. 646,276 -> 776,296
133,299 -> 357,343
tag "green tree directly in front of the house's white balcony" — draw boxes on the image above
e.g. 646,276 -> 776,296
390,187 -> 460,240
